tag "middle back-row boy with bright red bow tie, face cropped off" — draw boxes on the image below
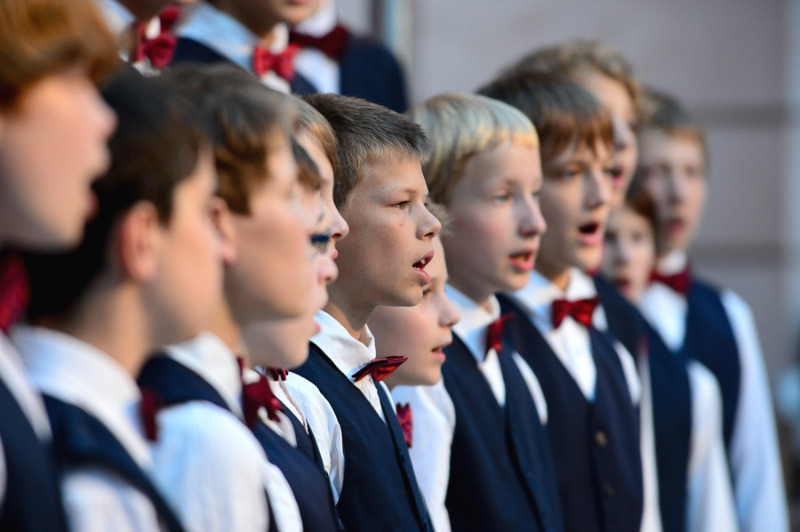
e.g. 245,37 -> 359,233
172,0 -> 315,94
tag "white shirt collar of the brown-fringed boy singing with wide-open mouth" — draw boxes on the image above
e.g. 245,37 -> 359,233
511,268 -> 597,328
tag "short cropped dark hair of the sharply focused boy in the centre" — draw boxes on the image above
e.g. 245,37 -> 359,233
304,94 -> 430,208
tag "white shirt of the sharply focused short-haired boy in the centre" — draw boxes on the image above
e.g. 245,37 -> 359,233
286,310 -> 389,502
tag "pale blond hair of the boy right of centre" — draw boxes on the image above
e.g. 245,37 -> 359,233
409,93 -> 539,205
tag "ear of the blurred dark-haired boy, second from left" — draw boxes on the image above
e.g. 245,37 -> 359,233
116,201 -> 162,283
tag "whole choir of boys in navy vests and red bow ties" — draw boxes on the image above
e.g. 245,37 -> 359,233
0,0 -> 788,532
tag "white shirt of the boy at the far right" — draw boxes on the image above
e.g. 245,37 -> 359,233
640,251 -> 789,532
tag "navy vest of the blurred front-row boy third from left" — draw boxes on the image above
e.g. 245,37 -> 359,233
139,356 -> 339,531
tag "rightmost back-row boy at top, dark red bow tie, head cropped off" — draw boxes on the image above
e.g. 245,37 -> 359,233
289,0 -> 408,113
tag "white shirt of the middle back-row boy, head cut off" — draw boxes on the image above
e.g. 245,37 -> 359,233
176,2 -> 291,94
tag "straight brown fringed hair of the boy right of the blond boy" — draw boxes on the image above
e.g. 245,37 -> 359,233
478,72 -> 613,169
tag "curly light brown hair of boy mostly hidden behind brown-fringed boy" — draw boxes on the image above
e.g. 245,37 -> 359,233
505,39 -> 642,117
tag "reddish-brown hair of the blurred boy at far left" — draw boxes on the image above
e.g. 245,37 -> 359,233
0,0 -> 119,110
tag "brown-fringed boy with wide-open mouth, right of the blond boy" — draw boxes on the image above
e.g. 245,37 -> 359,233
480,73 -> 643,532
